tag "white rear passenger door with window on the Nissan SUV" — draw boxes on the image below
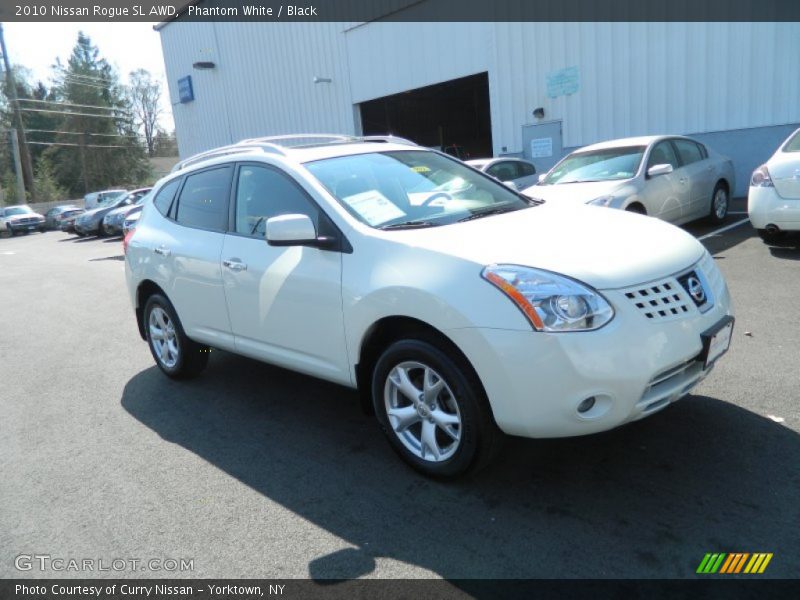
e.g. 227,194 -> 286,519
152,165 -> 233,348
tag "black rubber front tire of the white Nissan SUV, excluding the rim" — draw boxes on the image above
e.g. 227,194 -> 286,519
371,336 -> 503,478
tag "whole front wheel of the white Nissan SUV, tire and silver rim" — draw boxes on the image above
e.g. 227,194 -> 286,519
372,339 -> 502,477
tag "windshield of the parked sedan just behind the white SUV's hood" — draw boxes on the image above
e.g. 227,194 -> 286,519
539,146 -> 645,185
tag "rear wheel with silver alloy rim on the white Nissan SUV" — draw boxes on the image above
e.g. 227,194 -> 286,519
144,294 -> 209,379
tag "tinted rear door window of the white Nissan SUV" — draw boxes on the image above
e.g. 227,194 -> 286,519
175,166 -> 233,231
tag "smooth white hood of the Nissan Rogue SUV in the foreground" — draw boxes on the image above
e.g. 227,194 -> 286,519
382,204 -> 705,290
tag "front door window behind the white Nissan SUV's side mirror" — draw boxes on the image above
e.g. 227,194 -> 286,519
236,165 -> 319,238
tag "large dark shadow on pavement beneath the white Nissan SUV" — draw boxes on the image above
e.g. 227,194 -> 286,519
121,351 -> 800,580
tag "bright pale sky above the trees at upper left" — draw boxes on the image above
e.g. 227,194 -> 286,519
3,23 -> 175,131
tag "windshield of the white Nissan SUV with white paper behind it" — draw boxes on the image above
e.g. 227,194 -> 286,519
305,150 -> 531,229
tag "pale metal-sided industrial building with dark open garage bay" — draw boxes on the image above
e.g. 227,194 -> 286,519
158,15 -> 800,195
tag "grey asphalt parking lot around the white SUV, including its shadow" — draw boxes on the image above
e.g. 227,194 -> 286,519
0,202 -> 800,579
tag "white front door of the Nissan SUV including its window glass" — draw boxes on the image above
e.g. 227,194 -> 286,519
221,163 -> 350,384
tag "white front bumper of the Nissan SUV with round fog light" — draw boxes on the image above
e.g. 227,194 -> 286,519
445,257 -> 731,438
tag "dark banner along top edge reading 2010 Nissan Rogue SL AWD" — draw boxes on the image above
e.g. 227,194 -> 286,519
0,0 -> 800,23
